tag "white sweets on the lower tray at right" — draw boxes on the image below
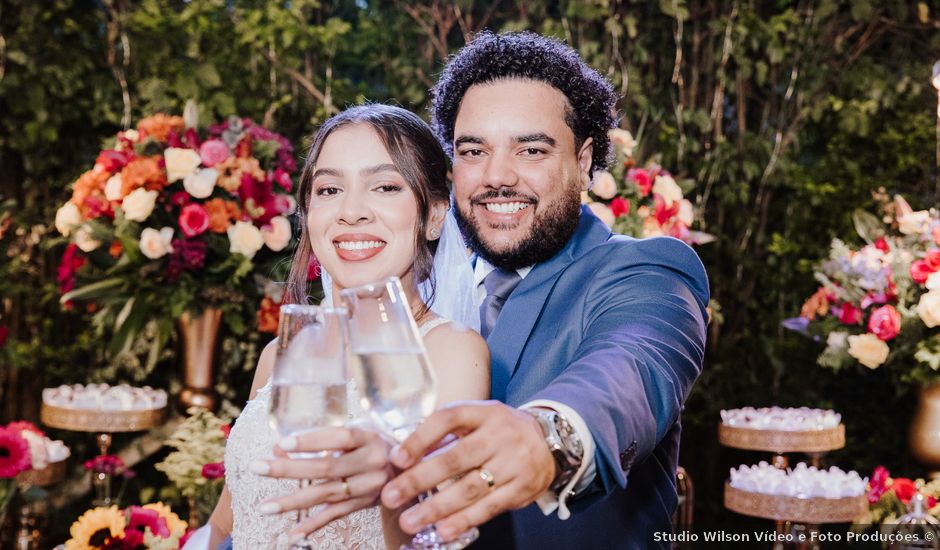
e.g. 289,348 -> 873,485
731,462 -> 868,498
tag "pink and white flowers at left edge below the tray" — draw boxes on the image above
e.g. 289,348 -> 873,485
0,420 -> 70,511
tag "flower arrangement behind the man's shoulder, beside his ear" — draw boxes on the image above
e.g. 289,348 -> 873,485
581,128 -> 714,245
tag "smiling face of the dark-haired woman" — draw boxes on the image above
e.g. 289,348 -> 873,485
307,124 -> 418,294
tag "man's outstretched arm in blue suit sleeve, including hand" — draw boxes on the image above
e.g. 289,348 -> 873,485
382,239 -> 708,539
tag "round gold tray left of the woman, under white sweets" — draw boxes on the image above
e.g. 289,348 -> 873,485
39,403 -> 166,433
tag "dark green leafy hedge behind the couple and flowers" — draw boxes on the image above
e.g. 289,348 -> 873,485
0,0 -> 940,541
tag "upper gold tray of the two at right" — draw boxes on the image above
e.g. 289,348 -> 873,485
718,423 -> 845,453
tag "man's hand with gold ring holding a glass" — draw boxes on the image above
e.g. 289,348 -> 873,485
382,401 -> 555,540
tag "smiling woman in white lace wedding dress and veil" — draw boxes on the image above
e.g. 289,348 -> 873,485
209,104 -> 489,550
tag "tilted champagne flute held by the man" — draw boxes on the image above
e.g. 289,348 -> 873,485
340,277 -> 479,550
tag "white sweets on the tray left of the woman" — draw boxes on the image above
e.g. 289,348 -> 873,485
42,384 -> 167,412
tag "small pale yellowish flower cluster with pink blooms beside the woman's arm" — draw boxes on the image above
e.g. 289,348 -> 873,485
156,407 -> 231,517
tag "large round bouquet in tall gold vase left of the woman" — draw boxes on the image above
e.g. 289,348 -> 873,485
55,114 -> 296,361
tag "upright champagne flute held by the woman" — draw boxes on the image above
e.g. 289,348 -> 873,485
269,304 -> 348,549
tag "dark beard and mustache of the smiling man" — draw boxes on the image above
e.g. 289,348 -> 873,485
454,185 -> 581,270
